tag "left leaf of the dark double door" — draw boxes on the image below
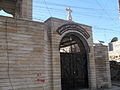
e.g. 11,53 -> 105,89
61,53 -> 73,90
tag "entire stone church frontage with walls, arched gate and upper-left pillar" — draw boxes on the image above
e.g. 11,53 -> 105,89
0,0 -> 111,90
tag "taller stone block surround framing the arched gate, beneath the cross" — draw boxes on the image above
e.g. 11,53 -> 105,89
45,18 -> 96,90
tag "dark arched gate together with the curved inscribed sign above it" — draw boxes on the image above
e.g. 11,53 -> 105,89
57,24 -> 90,90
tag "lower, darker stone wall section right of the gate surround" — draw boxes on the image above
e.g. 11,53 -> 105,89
94,44 -> 111,88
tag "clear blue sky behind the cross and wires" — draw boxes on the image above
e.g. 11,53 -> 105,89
0,0 -> 120,42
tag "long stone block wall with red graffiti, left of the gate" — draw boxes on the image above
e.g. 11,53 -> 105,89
0,16 -> 49,90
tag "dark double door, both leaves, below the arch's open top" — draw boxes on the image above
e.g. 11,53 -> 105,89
60,53 -> 88,90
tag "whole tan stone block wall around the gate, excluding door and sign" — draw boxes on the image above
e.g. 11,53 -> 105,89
0,16 -> 111,90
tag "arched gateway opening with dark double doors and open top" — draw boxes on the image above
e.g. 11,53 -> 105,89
60,33 -> 88,90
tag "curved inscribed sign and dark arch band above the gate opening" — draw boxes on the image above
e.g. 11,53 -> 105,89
57,23 -> 90,53
